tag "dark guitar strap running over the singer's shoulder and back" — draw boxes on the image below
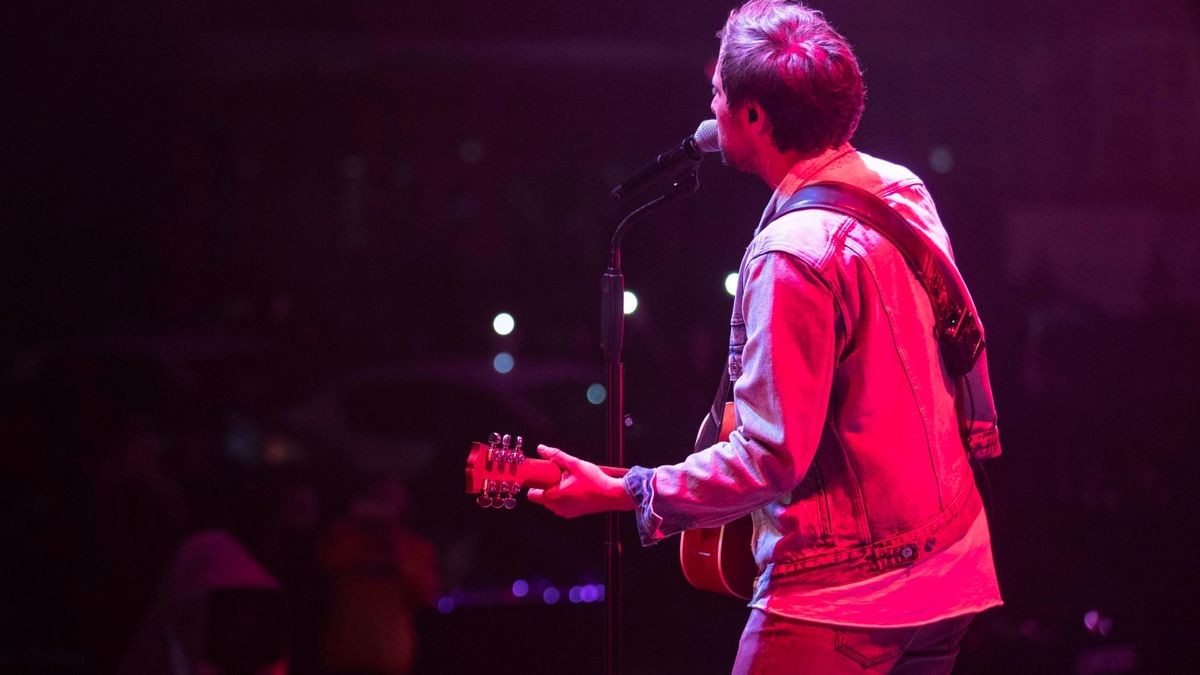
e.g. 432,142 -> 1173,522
696,181 -> 1001,459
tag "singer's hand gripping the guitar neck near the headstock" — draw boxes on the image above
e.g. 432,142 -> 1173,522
529,446 -> 634,518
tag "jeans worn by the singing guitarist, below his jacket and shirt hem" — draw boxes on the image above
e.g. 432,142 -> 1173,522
733,609 -> 974,675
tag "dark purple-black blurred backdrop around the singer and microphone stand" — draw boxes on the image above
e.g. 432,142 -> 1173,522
7,0 -> 1200,674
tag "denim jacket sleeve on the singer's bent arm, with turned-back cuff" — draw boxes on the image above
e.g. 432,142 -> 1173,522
625,250 -> 839,545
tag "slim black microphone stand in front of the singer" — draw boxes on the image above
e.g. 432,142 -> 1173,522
600,162 -> 700,675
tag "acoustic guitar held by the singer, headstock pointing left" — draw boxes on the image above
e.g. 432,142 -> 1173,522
467,404 -> 758,599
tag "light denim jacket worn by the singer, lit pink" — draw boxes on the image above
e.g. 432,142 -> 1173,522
625,147 -> 1000,592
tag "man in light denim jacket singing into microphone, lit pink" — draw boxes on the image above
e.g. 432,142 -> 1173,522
529,0 -> 1001,674
